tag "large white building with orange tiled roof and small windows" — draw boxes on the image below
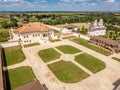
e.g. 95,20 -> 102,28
11,22 -> 54,44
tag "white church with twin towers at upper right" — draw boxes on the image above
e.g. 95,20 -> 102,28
88,19 -> 106,36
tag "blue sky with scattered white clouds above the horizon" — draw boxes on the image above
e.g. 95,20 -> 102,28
0,0 -> 120,11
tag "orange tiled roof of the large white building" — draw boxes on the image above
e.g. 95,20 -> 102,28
13,22 -> 53,34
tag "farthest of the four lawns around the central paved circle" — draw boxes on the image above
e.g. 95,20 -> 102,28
56,45 -> 81,54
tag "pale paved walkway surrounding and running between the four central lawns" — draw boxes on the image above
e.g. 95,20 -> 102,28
5,40 -> 120,90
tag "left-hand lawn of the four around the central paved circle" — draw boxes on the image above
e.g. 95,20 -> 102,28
38,48 -> 61,62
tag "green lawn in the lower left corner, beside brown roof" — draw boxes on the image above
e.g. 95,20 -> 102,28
8,67 -> 36,90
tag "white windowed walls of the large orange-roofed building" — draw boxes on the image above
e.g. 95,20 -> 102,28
13,30 -> 54,44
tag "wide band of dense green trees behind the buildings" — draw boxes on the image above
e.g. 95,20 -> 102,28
2,12 -> 120,28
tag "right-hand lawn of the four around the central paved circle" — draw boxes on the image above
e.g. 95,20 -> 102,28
75,53 -> 105,73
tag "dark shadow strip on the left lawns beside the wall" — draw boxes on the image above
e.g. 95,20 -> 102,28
2,49 -> 11,90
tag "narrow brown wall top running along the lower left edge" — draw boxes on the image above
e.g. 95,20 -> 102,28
0,46 -> 5,90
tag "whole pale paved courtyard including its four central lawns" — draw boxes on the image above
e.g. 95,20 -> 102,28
4,39 -> 120,90
